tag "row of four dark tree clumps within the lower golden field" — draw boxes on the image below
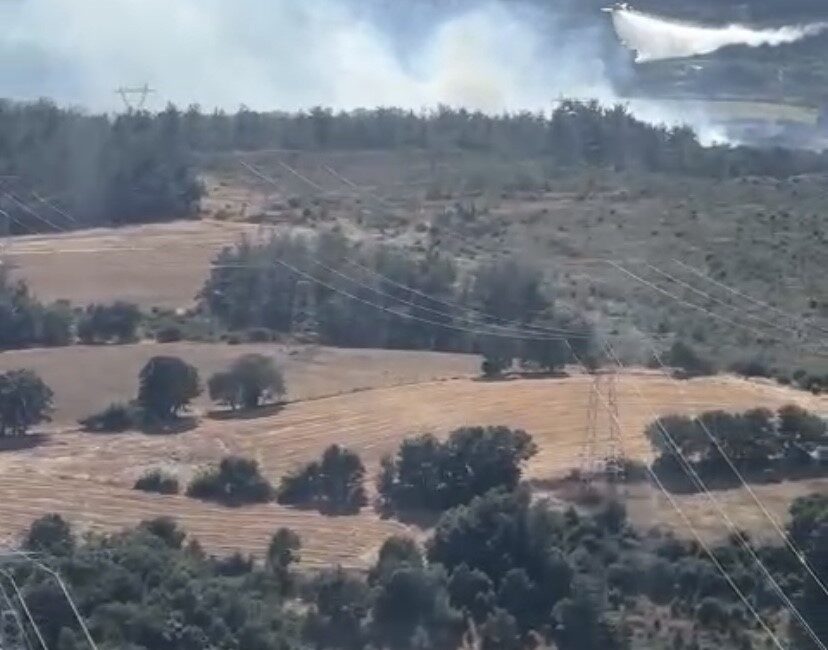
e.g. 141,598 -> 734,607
151,427 -> 537,515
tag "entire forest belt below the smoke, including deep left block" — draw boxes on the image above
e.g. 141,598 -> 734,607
0,101 -> 828,232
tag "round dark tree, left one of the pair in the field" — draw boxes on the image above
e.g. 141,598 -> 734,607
138,356 -> 201,420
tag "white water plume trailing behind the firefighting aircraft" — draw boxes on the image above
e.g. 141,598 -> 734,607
612,9 -> 828,63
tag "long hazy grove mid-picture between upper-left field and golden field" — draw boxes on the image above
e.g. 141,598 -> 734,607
200,232 -> 590,360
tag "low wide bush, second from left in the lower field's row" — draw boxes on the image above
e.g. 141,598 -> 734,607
187,456 -> 273,506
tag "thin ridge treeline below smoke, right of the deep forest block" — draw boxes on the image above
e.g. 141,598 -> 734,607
150,101 -> 827,177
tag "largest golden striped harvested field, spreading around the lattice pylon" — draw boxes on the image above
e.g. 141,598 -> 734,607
0,372 -> 828,567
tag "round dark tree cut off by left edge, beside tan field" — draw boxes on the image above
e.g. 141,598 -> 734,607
0,370 -> 54,436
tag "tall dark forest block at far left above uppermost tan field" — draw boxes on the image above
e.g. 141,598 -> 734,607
0,100 -> 203,234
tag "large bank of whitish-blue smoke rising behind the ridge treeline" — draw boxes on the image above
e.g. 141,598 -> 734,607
0,0 -> 719,140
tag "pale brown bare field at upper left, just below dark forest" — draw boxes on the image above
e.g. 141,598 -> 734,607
3,220 -> 257,308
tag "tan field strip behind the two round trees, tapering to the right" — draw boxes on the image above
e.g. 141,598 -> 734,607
0,342 -> 480,428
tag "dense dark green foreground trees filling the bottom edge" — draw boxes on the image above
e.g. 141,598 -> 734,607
14,490 -> 828,650
